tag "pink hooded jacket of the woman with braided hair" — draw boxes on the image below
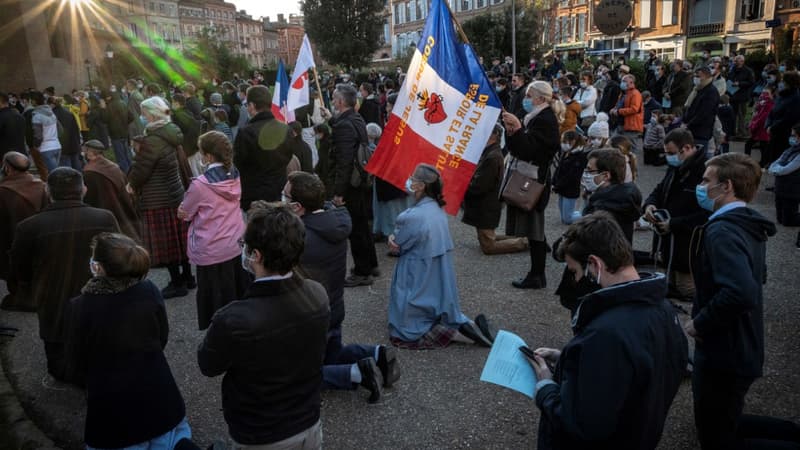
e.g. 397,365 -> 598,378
180,165 -> 245,266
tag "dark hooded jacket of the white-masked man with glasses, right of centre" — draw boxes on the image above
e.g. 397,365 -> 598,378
583,183 -> 642,243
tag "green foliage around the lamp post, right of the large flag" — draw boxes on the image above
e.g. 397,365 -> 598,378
461,2 -> 541,70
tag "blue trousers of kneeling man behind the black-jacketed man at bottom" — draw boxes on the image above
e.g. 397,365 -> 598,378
322,328 -> 376,390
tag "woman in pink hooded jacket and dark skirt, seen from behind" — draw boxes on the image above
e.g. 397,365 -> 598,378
178,131 -> 251,330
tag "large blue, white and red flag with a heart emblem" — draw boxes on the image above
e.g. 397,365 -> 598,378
367,0 -> 501,215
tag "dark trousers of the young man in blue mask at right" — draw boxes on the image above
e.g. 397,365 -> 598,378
692,367 -> 754,450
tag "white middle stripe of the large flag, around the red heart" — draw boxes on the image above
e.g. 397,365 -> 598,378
392,50 -> 500,164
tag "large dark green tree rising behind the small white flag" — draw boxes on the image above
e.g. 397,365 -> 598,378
301,0 -> 384,71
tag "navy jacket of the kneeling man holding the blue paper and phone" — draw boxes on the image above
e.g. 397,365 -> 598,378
535,274 -> 688,450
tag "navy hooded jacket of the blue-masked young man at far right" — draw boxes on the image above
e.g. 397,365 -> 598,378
692,207 -> 776,378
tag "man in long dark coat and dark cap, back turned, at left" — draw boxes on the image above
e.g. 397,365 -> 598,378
9,167 -> 119,380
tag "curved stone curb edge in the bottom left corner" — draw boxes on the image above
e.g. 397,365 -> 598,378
0,340 -> 58,450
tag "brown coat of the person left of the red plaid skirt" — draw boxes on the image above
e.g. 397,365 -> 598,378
83,156 -> 139,241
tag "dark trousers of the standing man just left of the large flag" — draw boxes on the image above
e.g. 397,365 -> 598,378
344,188 -> 378,276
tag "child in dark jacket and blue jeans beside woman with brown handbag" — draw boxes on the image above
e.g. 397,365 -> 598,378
553,130 -> 586,225
